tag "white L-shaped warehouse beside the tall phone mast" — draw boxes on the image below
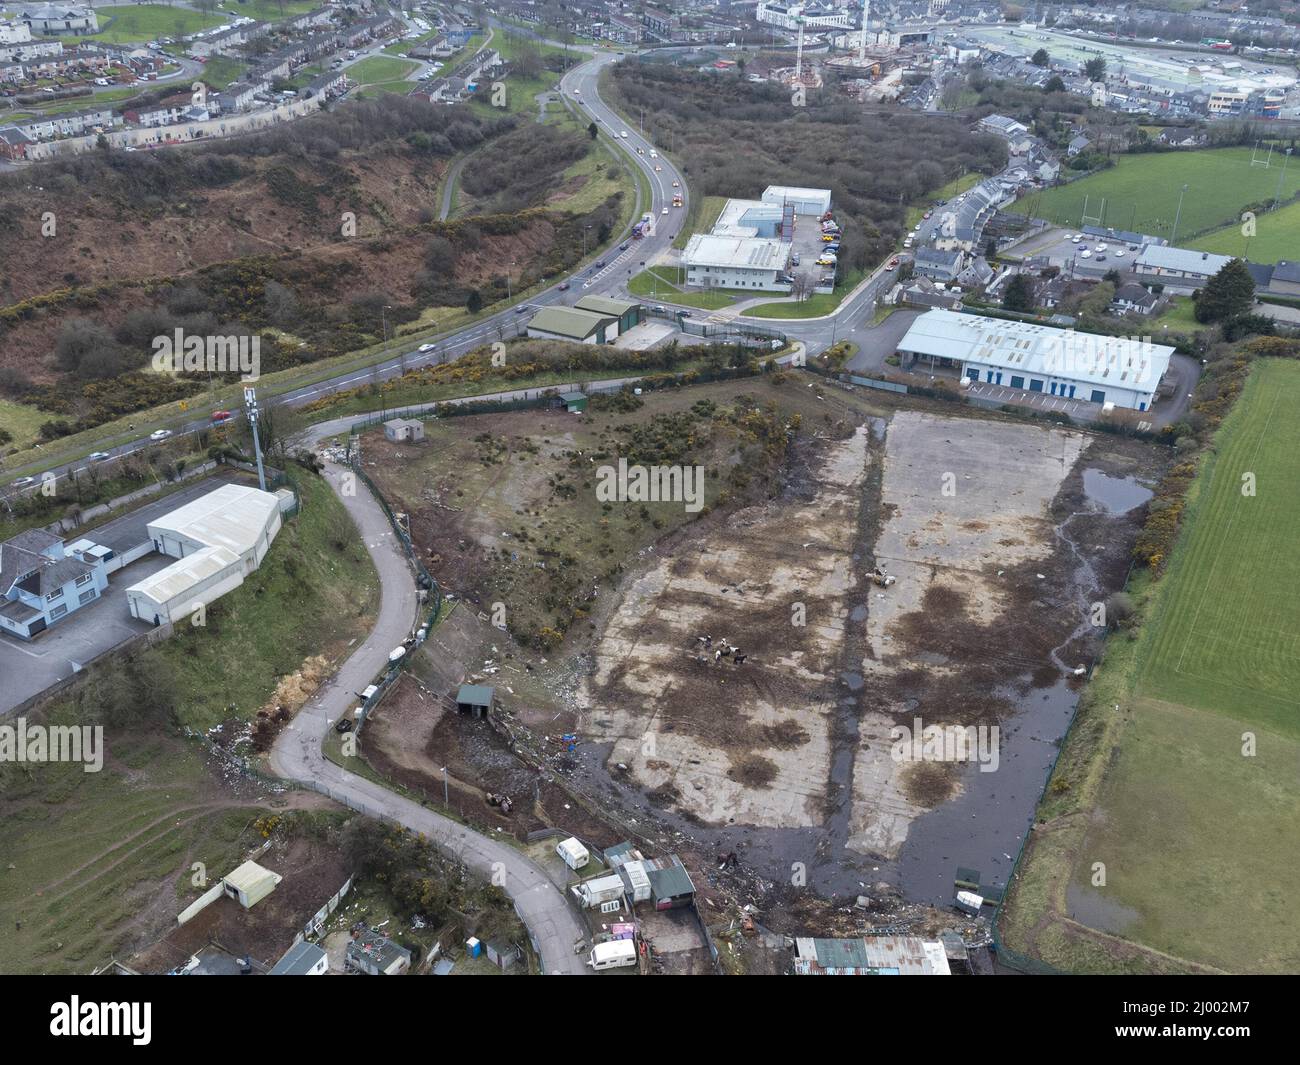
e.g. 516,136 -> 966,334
126,485 -> 281,624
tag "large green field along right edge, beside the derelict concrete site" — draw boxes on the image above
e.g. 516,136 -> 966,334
1002,359 -> 1300,973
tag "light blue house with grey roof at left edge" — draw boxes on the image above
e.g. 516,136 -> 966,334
0,529 -> 108,640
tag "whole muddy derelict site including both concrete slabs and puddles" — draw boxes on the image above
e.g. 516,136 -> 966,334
365,390 -> 1167,927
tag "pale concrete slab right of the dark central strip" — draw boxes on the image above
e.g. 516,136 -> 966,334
848,411 -> 1089,858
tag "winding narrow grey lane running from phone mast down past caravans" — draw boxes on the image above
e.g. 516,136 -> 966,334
270,419 -> 590,974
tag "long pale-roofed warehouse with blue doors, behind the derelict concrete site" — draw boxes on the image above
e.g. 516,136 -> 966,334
898,311 -> 1174,411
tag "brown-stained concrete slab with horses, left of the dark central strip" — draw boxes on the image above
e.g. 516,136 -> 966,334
581,427 -> 868,827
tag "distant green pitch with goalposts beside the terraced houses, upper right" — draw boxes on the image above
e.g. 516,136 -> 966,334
1011,148 -> 1300,241
